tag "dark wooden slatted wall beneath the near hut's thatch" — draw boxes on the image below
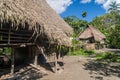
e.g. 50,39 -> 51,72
0,28 -> 33,44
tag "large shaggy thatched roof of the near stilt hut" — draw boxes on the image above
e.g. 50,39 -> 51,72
0,0 -> 73,46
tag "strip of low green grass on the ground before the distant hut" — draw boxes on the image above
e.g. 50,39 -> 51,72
68,49 -> 120,63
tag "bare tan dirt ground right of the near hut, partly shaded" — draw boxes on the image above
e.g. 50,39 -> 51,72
40,56 -> 120,80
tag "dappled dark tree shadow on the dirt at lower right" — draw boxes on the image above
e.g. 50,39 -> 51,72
83,60 -> 120,80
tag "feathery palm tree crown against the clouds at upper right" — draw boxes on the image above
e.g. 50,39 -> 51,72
108,1 -> 120,13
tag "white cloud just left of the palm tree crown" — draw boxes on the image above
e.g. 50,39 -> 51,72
95,0 -> 120,11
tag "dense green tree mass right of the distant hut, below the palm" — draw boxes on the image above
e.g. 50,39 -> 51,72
89,13 -> 120,48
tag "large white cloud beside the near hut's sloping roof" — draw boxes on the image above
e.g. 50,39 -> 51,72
46,0 -> 73,14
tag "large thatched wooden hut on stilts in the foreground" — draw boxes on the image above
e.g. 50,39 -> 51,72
0,0 -> 73,74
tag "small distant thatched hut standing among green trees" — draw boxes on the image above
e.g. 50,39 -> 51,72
78,26 -> 106,49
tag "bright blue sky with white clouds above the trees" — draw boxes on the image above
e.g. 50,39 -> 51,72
46,0 -> 120,22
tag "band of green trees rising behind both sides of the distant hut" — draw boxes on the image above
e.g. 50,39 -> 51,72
64,10 -> 120,48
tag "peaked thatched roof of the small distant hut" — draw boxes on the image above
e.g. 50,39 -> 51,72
78,26 -> 106,41
